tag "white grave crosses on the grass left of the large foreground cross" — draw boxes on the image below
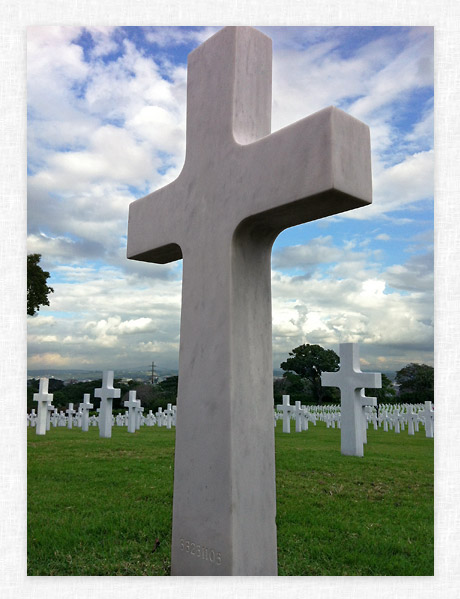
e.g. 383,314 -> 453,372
28,370 -> 176,439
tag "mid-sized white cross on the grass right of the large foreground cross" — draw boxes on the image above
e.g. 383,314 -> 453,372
321,343 -> 382,457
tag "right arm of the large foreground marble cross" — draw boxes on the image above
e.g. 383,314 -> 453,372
235,107 -> 372,237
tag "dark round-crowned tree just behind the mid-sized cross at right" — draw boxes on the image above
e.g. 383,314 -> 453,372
281,344 -> 340,404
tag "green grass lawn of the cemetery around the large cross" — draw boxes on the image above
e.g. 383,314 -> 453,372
27,421 -> 434,576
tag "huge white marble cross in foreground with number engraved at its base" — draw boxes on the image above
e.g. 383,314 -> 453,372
127,27 -> 372,576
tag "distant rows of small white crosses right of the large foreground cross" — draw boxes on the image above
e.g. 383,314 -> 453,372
275,395 -> 434,443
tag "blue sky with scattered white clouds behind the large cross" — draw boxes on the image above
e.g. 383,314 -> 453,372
28,27 -> 434,371
